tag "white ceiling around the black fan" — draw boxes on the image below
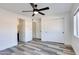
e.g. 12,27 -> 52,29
0,3 -> 72,16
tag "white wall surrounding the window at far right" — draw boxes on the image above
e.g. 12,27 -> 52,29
71,4 -> 79,54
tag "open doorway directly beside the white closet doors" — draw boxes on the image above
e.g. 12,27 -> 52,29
32,18 -> 41,41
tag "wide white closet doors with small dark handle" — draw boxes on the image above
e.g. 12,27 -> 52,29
42,19 -> 64,43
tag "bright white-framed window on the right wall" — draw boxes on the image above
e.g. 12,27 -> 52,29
74,8 -> 79,38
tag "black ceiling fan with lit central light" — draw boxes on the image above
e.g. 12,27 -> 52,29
22,3 -> 49,16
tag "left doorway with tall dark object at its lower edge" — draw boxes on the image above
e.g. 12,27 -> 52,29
17,19 -> 25,43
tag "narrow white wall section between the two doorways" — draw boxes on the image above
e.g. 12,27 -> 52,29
25,17 -> 32,42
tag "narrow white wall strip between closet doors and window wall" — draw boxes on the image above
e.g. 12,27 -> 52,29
64,13 -> 72,45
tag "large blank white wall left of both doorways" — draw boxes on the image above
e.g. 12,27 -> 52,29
0,9 -> 17,50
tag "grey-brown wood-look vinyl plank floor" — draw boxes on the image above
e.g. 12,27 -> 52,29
0,41 -> 75,55
